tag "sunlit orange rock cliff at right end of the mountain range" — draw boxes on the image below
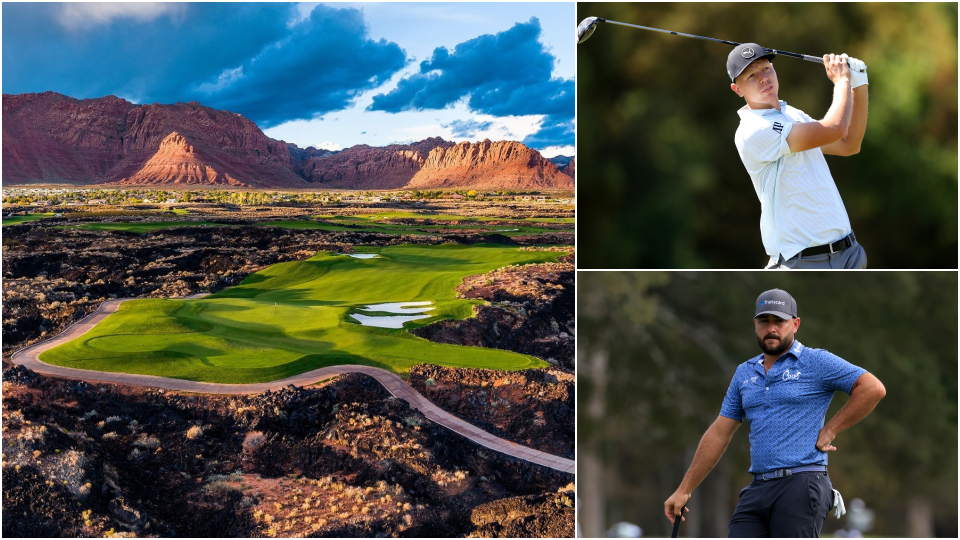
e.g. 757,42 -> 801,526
409,139 -> 573,189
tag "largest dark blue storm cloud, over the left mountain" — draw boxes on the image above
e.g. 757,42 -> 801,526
3,3 -> 406,128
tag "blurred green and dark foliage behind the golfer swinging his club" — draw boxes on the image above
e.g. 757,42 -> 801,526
571,2 -> 957,269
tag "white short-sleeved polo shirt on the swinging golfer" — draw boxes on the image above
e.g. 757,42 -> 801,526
734,100 -> 851,265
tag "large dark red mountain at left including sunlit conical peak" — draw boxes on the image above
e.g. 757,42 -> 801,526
3,92 -> 306,187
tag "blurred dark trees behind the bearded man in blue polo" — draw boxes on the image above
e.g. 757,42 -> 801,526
577,271 -> 958,538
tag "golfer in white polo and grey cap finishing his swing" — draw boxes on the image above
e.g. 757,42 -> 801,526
727,43 -> 868,268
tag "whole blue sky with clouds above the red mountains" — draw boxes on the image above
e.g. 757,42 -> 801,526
2,2 -> 576,157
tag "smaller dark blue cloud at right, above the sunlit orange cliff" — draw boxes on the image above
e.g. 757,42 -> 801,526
369,18 -> 575,148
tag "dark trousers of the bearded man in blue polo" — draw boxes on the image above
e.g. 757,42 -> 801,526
727,472 -> 833,538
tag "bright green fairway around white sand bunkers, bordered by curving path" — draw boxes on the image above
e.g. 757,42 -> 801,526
40,244 -> 564,383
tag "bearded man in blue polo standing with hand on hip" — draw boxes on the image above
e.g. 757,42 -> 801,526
664,289 -> 886,538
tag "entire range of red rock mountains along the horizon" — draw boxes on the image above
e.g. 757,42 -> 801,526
3,92 -> 573,190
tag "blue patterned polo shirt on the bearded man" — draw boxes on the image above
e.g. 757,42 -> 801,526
720,341 -> 867,473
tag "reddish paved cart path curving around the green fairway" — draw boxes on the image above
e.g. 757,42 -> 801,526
11,295 -> 576,474
